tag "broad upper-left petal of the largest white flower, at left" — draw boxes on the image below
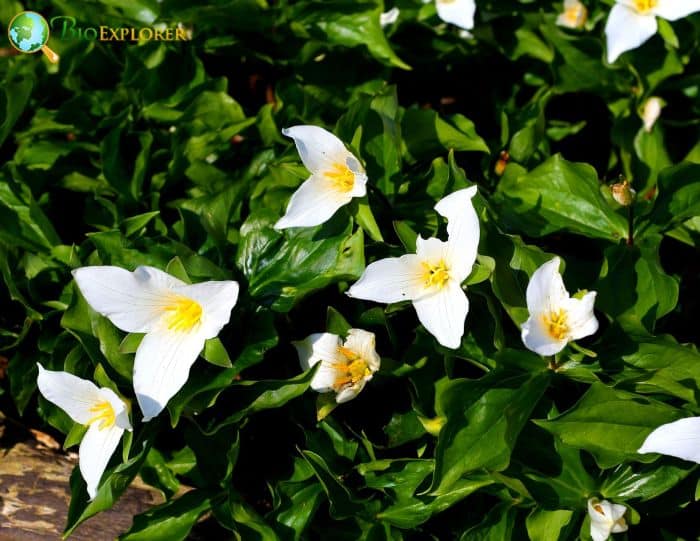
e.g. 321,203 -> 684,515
73,266 -> 184,333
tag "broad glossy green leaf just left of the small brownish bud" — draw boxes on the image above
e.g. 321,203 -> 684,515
494,155 -> 627,242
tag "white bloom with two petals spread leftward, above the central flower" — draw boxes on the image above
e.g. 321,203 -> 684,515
275,126 -> 367,229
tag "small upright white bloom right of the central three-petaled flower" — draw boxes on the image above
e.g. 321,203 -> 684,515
522,257 -> 598,356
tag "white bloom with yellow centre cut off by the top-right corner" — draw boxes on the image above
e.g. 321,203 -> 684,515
605,0 -> 700,64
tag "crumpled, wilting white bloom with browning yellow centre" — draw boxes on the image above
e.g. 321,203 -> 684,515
292,329 -> 381,404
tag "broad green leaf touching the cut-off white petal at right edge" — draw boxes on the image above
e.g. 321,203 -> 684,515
535,383 -> 682,468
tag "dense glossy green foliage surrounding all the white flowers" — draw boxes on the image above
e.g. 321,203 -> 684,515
0,0 -> 700,541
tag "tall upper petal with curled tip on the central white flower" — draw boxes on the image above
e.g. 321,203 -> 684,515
435,186 -> 479,283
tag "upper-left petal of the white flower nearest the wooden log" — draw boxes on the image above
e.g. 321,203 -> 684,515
37,363 -> 103,425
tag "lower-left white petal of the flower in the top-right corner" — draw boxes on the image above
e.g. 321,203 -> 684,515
605,0 -> 660,64
